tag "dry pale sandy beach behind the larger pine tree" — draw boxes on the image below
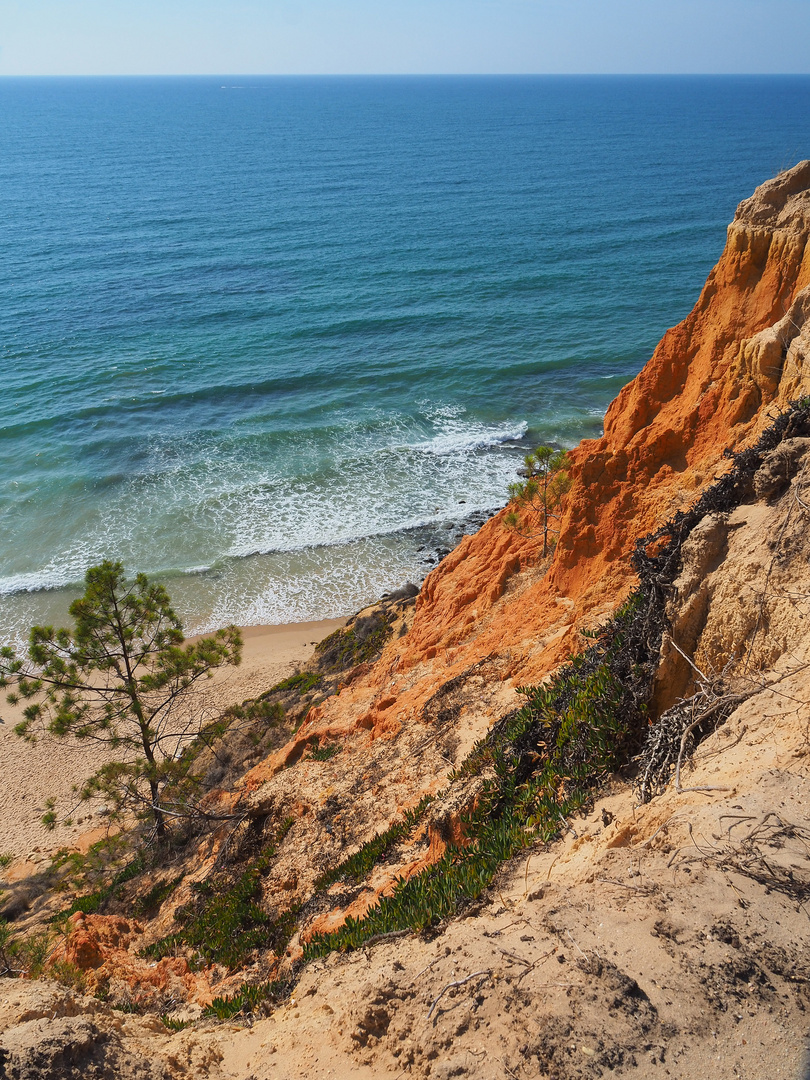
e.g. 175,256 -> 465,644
0,619 -> 346,872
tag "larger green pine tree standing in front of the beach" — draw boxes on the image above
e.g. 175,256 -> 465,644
0,562 -> 242,837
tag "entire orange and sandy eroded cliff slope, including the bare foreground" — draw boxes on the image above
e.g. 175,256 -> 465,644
0,162 -> 810,1080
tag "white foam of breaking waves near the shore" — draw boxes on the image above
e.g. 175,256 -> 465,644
0,402 -> 527,618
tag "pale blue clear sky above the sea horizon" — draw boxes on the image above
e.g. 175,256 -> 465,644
0,0 -> 810,76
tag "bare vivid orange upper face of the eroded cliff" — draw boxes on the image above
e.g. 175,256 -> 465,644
261,162 -> 810,764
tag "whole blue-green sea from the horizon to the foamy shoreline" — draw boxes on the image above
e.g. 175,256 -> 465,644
0,77 -> 810,639
